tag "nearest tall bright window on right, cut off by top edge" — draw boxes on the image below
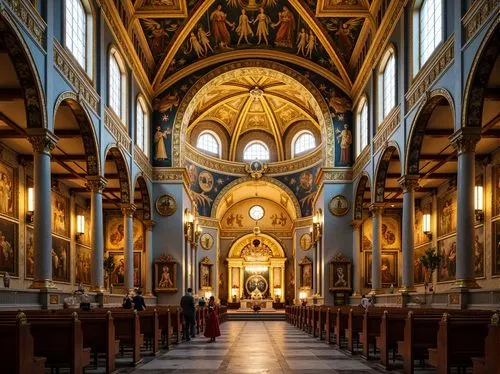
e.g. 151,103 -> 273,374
414,0 -> 443,68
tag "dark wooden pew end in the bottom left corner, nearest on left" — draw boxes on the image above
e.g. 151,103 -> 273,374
0,313 -> 45,374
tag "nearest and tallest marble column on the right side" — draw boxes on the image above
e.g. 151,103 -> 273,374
450,127 -> 481,289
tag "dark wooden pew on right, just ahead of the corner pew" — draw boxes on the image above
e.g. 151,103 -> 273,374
429,313 -> 490,374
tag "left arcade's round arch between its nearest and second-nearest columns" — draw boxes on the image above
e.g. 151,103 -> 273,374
54,92 -> 102,175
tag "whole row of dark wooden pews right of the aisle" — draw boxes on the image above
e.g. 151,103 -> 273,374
286,305 -> 500,374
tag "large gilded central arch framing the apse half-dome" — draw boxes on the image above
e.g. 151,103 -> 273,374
172,60 -> 335,167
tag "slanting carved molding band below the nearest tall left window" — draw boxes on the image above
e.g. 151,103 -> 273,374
54,38 -> 100,113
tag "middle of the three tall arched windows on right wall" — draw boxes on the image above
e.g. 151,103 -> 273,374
377,48 -> 396,123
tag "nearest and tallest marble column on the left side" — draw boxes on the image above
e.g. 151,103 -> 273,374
27,128 -> 59,289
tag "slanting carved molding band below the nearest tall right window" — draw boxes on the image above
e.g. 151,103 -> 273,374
405,34 -> 455,112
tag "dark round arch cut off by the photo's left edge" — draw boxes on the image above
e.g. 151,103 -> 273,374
0,12 -> 47,128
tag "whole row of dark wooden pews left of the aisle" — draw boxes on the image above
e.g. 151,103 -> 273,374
0,306 -> 227,374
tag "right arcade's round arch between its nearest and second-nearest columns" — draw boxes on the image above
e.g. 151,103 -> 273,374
404,88 -> 455,175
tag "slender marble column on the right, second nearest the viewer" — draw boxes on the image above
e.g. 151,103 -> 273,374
398,175 -> 419,292
